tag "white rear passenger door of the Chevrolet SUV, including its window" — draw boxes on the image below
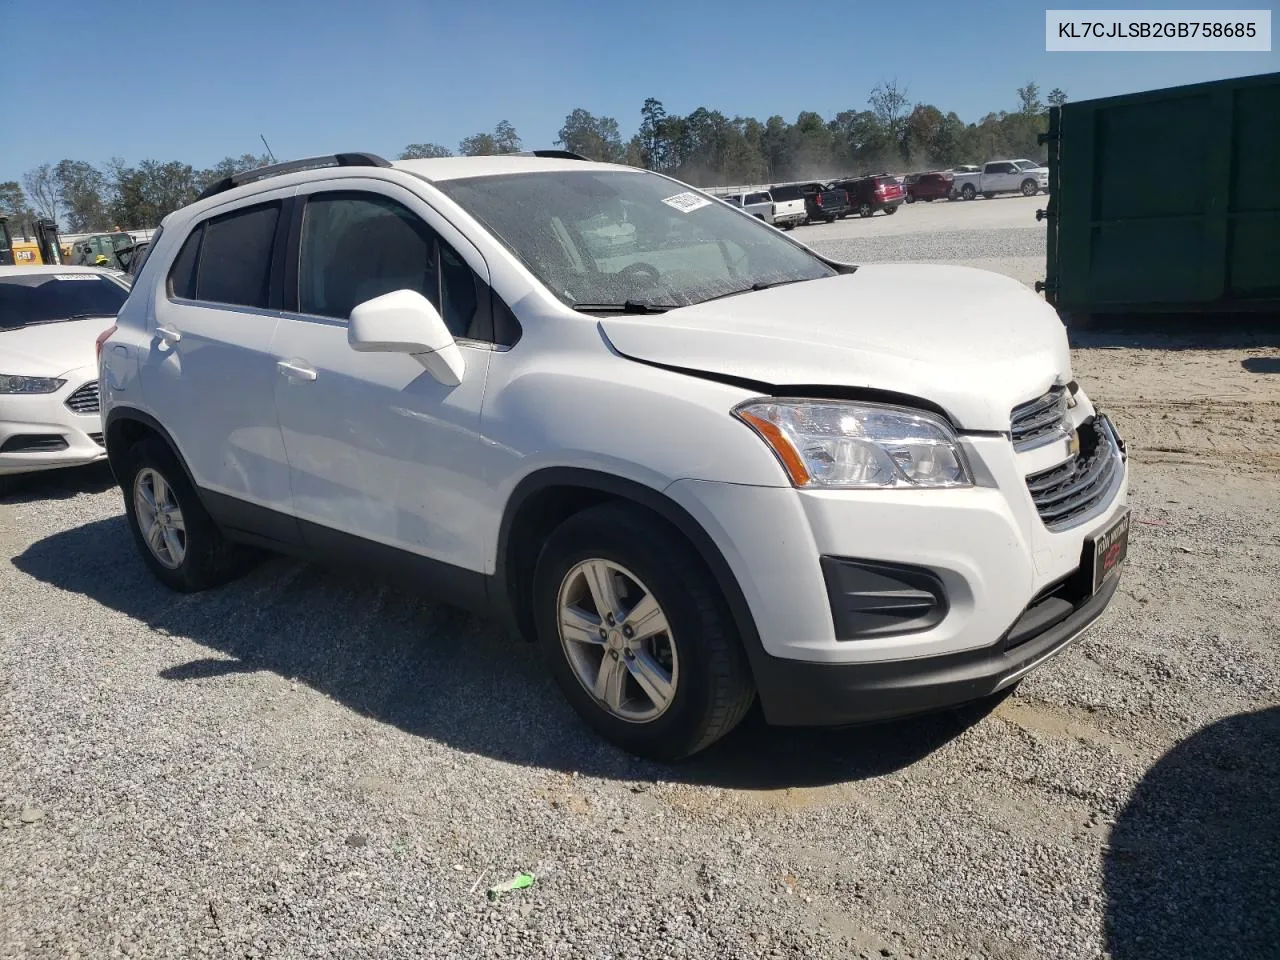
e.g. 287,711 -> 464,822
138,188 -> 293,527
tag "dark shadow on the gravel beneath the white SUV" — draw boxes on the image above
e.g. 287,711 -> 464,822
13,516 -> 995,790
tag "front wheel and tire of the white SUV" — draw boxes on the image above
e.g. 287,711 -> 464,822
532,504 -> 755,760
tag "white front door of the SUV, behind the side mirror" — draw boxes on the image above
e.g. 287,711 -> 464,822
271,180 -> 492,571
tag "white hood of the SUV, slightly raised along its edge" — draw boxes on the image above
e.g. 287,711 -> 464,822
600,264 -> 1071,431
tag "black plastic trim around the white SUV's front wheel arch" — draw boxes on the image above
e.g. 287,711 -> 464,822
490,467 -> 764,671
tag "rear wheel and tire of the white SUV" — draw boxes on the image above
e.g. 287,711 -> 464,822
120,436 -> 247,593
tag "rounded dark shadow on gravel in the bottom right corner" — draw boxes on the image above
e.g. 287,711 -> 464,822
1103,708 -> 1280,960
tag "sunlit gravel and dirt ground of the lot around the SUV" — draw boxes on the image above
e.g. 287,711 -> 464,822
0,197 -> 1280,960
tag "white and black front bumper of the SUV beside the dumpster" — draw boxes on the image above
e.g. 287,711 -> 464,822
667,407 -> 1128,723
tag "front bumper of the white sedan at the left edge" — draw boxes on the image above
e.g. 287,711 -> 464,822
0,369 -> 106,476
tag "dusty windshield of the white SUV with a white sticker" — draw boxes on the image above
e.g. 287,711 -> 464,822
435,170 -> 836,308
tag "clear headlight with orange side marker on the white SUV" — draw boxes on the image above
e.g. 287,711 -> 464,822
733,399 -> 973,488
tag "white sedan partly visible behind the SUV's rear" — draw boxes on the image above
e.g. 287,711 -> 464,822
0,266 -> 129,493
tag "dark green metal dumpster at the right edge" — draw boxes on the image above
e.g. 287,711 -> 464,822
1037,73 -> 1280,323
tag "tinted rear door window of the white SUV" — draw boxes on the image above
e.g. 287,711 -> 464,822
196,202 -> 280,308
